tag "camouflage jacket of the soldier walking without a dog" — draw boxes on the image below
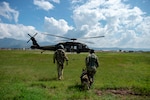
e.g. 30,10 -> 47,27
53,49 -> 68,64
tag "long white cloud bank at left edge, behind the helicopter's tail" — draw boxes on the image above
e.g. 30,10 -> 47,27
0,23 -> 42,40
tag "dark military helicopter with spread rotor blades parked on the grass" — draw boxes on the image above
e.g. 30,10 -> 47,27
27,33 -> 104,53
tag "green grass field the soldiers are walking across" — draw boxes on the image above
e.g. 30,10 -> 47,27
0,50 -> 150,100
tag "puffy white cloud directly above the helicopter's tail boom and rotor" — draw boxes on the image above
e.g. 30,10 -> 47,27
44,17 -> 73,35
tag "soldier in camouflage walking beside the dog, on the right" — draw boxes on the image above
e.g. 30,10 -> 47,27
85,49 -> 99,86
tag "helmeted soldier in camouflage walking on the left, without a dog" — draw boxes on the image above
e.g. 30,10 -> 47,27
53,45 -> 68,80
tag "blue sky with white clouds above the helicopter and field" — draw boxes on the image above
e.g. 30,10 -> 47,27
0,0 -> 150,49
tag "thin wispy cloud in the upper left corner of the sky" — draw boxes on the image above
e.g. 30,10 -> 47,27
0,2 -> 19,22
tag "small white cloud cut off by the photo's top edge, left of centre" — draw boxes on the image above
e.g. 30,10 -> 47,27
34,0 -> 54,11
